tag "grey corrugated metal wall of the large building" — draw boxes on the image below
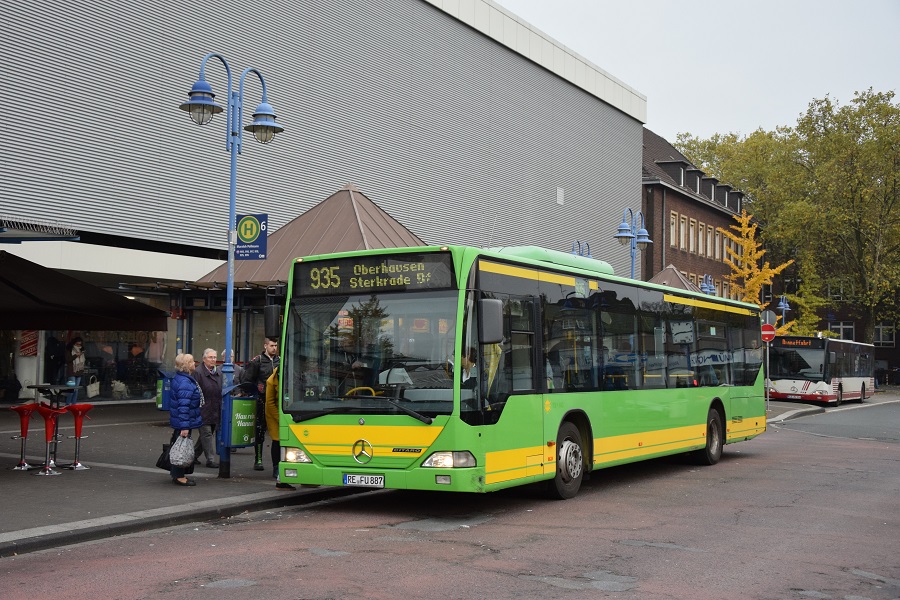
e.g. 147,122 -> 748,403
0,0 -> 642,272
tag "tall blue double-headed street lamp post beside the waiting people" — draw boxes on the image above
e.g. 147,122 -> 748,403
179,52 -> 284,478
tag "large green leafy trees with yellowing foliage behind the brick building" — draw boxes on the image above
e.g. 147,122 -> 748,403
675,89 -> 900,342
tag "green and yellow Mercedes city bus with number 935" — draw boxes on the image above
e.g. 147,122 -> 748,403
266,246 -> 766,498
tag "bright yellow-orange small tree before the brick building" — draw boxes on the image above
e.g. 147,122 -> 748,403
717,210 -> 794,312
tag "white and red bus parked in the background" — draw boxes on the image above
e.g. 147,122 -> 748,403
767,336 -> 875,406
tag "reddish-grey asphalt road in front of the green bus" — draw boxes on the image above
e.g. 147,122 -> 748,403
0,394 -> 900,600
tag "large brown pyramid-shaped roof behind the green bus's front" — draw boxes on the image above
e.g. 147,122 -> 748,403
197,183 -> 426,284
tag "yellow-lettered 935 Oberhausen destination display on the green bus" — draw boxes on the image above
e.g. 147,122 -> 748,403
294,253 -> 453,296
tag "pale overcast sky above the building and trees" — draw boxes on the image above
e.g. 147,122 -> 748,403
494,0 -> 900,142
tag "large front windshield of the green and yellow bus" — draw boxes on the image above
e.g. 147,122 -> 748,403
281,290 -> 458,423
